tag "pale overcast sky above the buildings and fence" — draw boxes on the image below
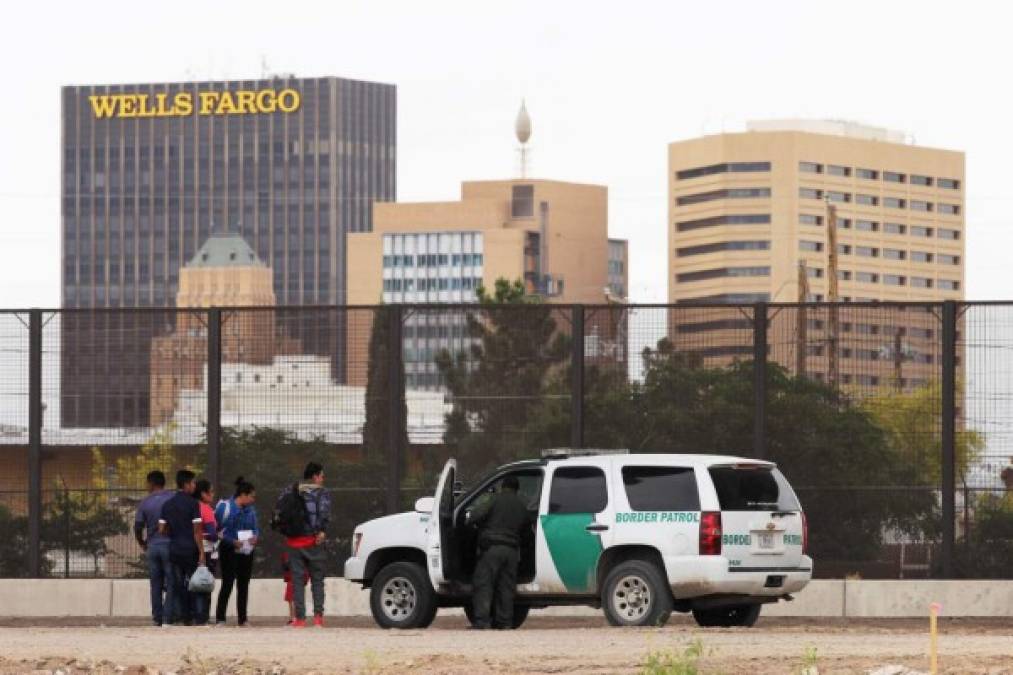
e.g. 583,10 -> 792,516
0,0 -> 1013,307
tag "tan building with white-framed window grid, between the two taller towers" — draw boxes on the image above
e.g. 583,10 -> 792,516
346,178 -> 628,388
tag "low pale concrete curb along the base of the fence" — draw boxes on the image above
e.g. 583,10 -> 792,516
0,579 -> 1013,618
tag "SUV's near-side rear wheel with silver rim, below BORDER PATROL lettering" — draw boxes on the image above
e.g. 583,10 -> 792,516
602,559 -> 673,626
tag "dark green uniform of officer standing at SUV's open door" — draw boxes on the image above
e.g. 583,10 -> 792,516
471,490 -> 532,628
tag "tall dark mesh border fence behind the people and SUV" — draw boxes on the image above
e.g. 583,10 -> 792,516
0,302 -> 1013,579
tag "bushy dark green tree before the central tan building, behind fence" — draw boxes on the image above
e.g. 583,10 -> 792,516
437,279 -> 569,477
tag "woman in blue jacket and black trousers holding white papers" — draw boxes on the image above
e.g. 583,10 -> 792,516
215,476 -> 260,625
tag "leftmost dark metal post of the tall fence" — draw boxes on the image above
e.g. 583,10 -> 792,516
27,309 -> 43,577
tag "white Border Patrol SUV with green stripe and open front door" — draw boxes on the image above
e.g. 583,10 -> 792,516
344,450 -> 812,628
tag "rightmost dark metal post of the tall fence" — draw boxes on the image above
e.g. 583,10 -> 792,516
940,300 -> 952,579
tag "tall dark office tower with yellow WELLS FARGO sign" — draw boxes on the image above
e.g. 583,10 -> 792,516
61,77 -> 396,427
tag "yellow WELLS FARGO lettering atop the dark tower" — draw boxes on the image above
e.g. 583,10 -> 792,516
88,89 -> 302,120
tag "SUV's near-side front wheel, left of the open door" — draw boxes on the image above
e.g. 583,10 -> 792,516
370,563 -> 438,628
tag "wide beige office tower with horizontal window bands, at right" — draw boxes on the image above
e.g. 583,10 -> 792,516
668,121 -> 965,385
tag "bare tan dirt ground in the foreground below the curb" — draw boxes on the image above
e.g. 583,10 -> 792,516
0,615 -> 1013,675
